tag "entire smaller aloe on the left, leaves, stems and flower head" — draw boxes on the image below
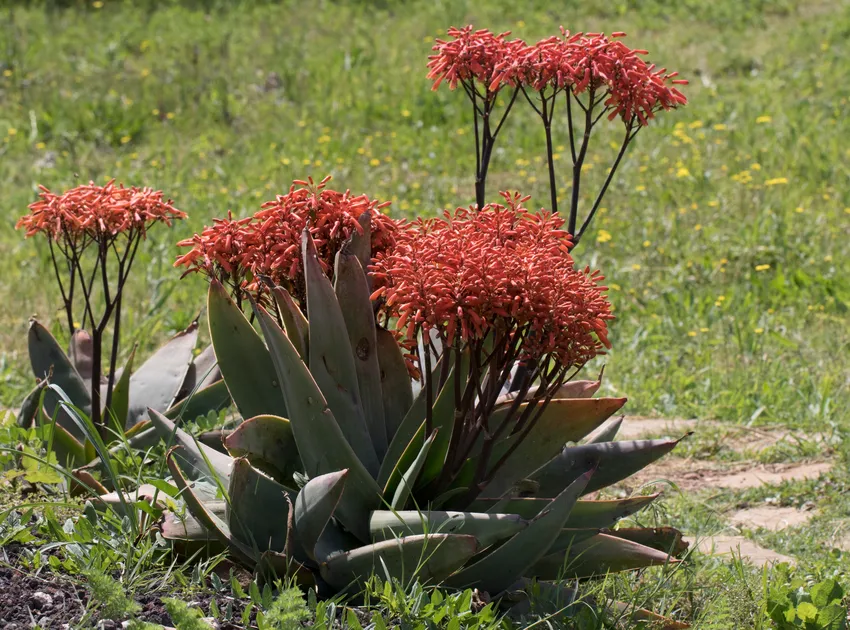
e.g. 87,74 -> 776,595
18,182 -> 227,472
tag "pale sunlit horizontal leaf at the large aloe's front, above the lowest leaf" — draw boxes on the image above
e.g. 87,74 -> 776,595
369,512 -> 524,549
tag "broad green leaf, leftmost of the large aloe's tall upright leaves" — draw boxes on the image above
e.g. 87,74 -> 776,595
207,280 -> 287,418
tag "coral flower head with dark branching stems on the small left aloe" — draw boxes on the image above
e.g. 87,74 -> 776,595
16,181 -> 186,426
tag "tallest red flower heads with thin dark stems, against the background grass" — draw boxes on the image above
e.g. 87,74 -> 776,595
428,26 -> 687,246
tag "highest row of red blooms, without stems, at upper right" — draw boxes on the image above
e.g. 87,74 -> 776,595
428,26 -> 687,125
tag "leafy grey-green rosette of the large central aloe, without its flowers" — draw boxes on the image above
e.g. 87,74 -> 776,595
150,223 -> 683,595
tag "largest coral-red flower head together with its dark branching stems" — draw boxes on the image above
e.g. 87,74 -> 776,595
371,193 -> 613,498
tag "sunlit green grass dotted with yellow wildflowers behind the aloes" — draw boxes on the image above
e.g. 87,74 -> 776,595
0,0 -> 850,628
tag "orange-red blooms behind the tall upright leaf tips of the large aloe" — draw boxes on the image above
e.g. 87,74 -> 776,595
174,177 -> 396,297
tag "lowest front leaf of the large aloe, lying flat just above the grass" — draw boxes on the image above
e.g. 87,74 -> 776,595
319,534 -> 478,590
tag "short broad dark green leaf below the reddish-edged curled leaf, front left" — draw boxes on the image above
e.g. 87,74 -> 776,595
227,457 -> 292,553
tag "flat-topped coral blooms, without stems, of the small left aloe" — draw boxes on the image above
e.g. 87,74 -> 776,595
15,180 -> 186,239
